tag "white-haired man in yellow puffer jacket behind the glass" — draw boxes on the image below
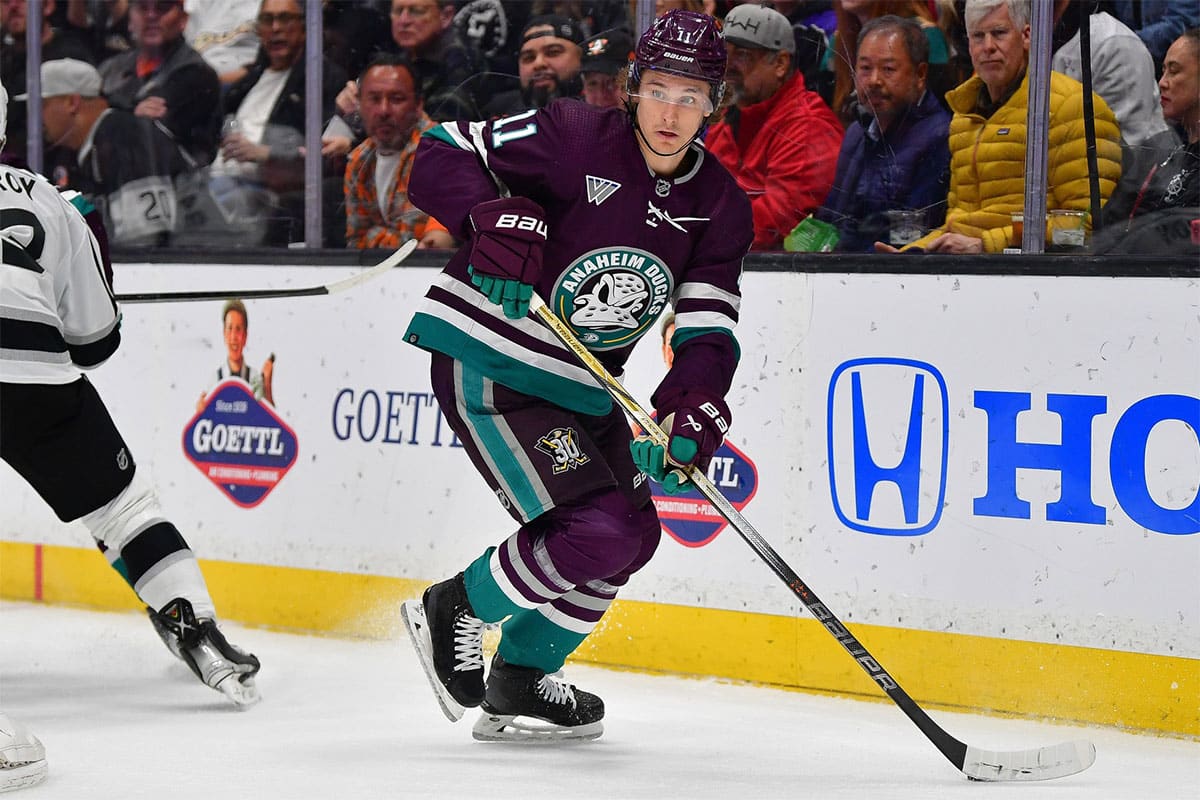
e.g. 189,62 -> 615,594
875,0 -> 1121,253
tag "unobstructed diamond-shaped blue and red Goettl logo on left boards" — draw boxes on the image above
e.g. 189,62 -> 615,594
184,378 -> 298,509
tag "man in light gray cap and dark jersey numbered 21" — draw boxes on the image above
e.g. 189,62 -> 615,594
22,59 -> 185,247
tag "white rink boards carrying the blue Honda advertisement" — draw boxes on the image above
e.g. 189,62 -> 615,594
0,264 -> 1200,657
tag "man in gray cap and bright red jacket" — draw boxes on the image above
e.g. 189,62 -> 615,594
704,4 -> 842,251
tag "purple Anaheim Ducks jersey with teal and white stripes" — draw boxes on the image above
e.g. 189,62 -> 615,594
406,100 -> 754,414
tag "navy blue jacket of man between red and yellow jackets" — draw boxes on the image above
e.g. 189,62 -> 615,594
816,91 -> 950,252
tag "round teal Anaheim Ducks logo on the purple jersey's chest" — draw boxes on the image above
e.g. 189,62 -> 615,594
551,247 -> 673,350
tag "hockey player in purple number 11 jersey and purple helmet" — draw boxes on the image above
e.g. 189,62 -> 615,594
402,11 -> 754,740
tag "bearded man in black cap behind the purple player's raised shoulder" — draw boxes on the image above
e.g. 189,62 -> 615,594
484,14 -> 584,119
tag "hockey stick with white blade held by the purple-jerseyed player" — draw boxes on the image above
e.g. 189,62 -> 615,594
529,294 -> 1096,781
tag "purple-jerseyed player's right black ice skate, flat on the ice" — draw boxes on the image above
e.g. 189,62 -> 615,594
472,654 -> 604,742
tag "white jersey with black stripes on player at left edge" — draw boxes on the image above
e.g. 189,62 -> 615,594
0,164 -> 120,384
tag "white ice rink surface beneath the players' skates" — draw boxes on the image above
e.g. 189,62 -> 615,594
0,602 -> 1200,800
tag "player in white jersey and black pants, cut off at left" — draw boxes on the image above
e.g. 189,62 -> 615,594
0,86 -> 259,706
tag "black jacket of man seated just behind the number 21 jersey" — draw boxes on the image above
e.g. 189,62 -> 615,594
100,37 -> 221,164
